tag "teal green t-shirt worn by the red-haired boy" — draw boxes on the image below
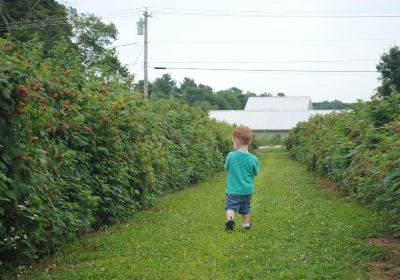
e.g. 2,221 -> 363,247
224,151 -> 259,195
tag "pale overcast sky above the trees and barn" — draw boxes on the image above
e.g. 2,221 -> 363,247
59,0 -> 400,102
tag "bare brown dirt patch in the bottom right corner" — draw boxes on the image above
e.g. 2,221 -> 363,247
368,237 -> 400,280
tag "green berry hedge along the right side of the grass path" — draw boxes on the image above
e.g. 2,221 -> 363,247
286,92 -> 400,235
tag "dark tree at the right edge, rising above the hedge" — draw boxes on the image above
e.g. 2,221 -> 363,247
376,46 -> 400,97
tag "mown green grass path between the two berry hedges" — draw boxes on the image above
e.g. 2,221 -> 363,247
11,153 -> 385,279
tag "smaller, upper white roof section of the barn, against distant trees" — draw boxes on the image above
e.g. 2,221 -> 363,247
244,96 -> 313,111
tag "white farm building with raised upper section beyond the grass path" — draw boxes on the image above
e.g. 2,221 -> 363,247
209,97 -> 333,138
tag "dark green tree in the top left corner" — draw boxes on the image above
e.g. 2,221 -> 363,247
0,0 -> 72,53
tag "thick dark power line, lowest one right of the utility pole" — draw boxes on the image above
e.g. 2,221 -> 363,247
154,66 -> 378,73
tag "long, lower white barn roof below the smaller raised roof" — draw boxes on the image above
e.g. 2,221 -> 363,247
209,110 -> 338,131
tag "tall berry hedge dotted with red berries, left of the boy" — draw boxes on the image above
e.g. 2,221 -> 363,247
0,39 -> 231,268
